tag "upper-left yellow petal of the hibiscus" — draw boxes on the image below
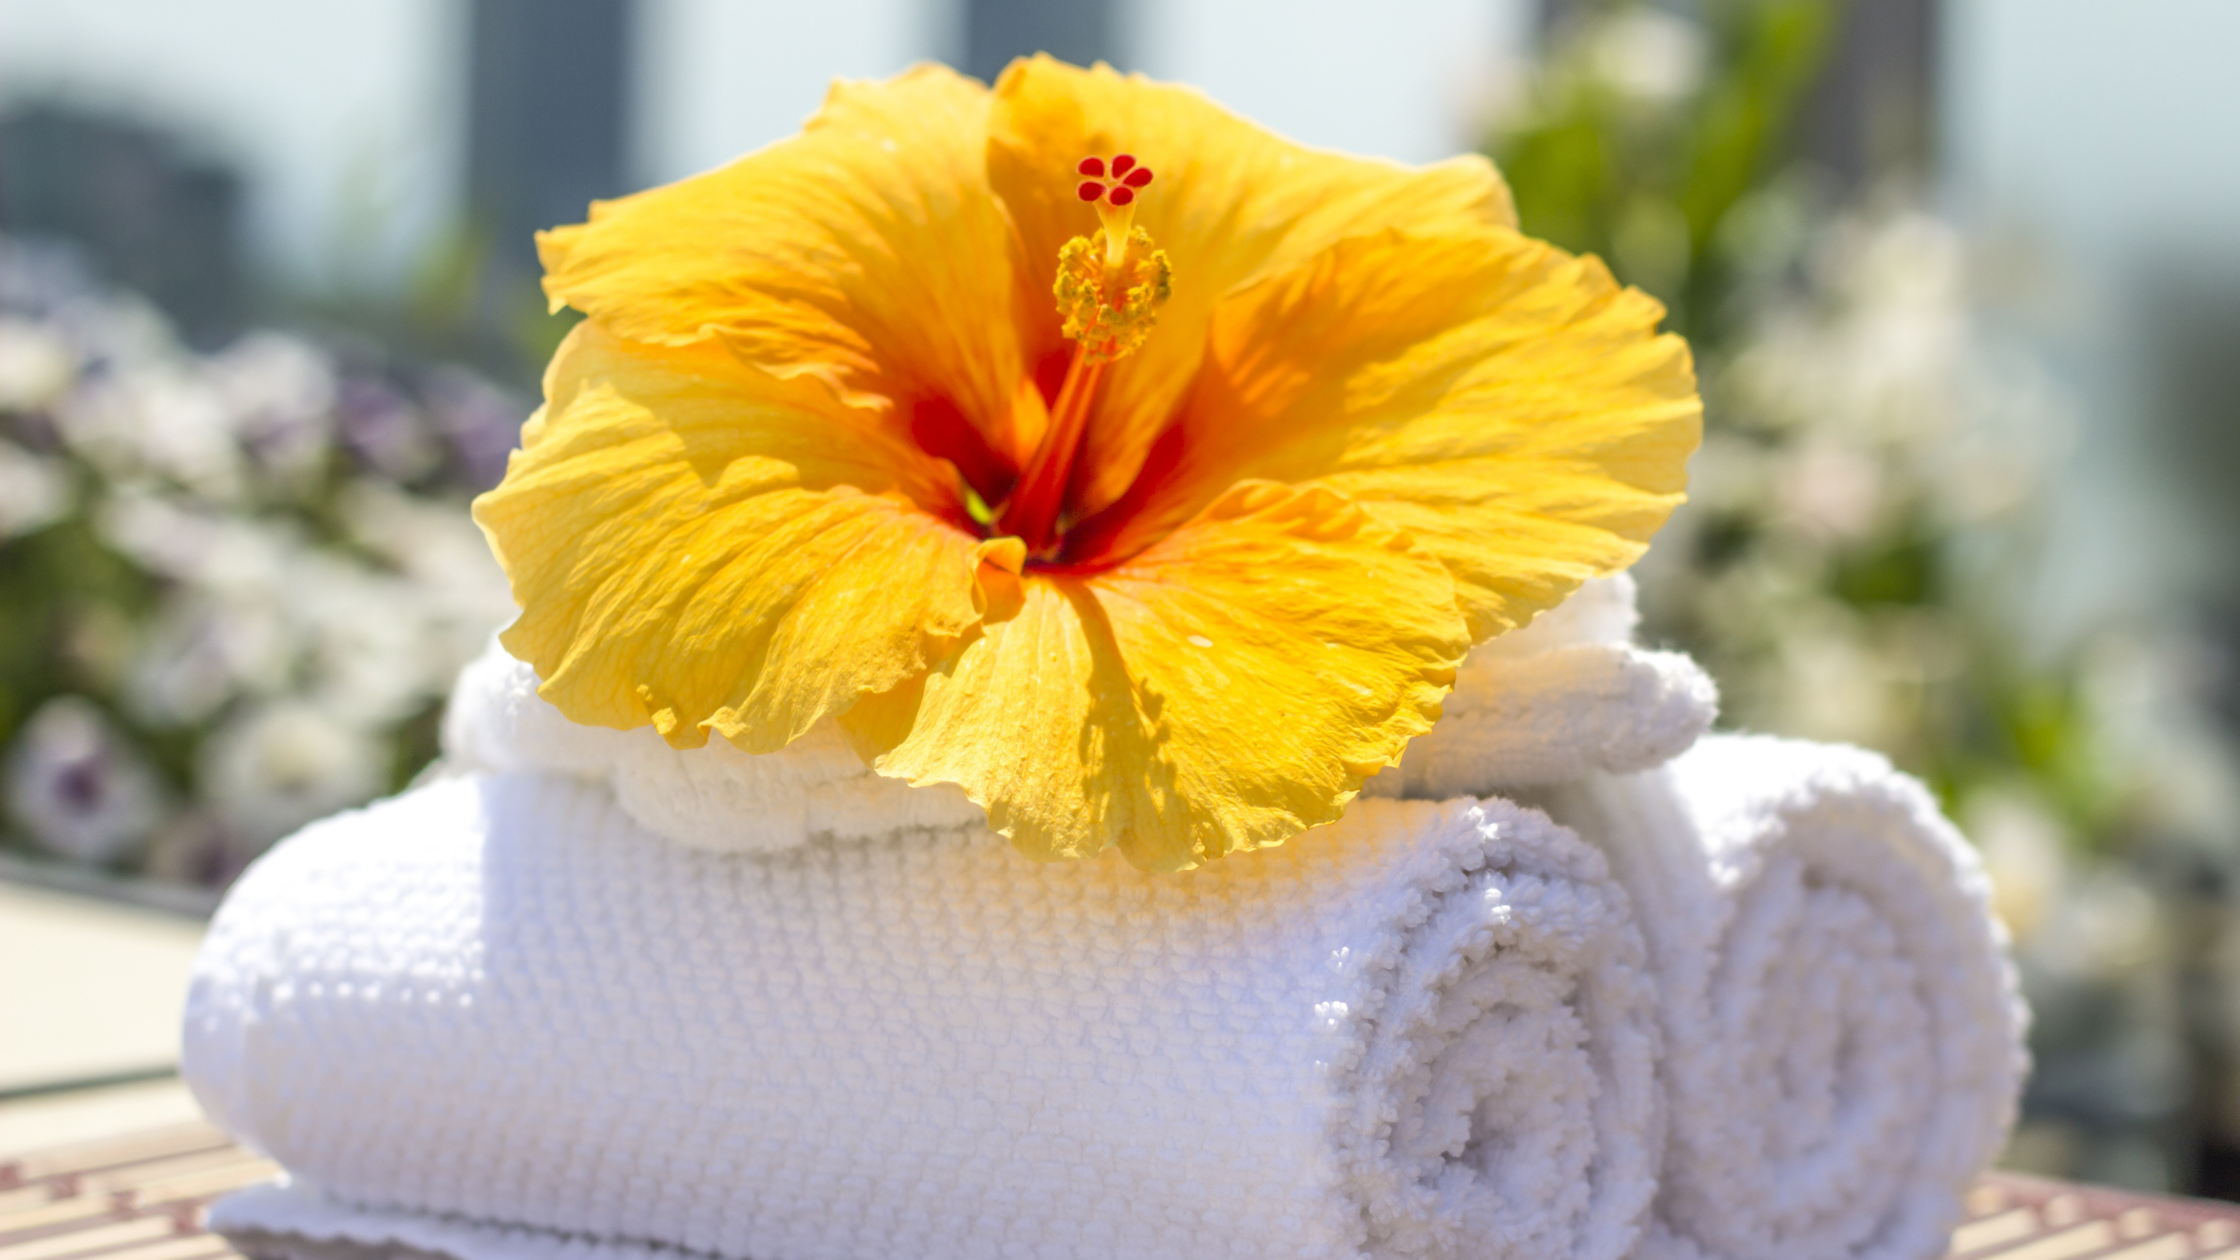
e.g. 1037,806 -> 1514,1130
538,65 -> 1025,446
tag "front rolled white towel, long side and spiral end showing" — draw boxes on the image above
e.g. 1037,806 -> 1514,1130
186,773 -> 1662,1260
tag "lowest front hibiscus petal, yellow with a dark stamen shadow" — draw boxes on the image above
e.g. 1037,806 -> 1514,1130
842,482 -> 1469,870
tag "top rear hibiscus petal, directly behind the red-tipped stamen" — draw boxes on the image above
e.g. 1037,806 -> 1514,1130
988,56 -> 1516,511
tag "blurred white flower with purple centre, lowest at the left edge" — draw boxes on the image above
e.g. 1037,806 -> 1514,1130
7,695 -> 164,863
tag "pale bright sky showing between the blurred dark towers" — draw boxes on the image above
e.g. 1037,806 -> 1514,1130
0,0 -> 2240,293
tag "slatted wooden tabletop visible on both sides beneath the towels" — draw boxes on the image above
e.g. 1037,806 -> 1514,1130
0,1125 -> 2240,1260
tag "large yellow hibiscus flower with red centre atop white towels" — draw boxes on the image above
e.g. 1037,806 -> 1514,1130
475,58 -> 1700,870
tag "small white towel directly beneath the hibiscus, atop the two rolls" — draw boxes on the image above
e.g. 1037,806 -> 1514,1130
444,574 -> 1718,852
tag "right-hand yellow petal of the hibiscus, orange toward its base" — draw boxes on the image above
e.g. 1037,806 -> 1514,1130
1080,229 -> 1702,639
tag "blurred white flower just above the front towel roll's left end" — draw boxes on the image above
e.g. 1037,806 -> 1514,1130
199,700 -> 390,850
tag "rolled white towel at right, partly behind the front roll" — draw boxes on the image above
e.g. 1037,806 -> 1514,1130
1543,735 -> 2027,1260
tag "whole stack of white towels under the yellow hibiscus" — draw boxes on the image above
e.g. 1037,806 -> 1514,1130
186,578 -> 2023,1260
